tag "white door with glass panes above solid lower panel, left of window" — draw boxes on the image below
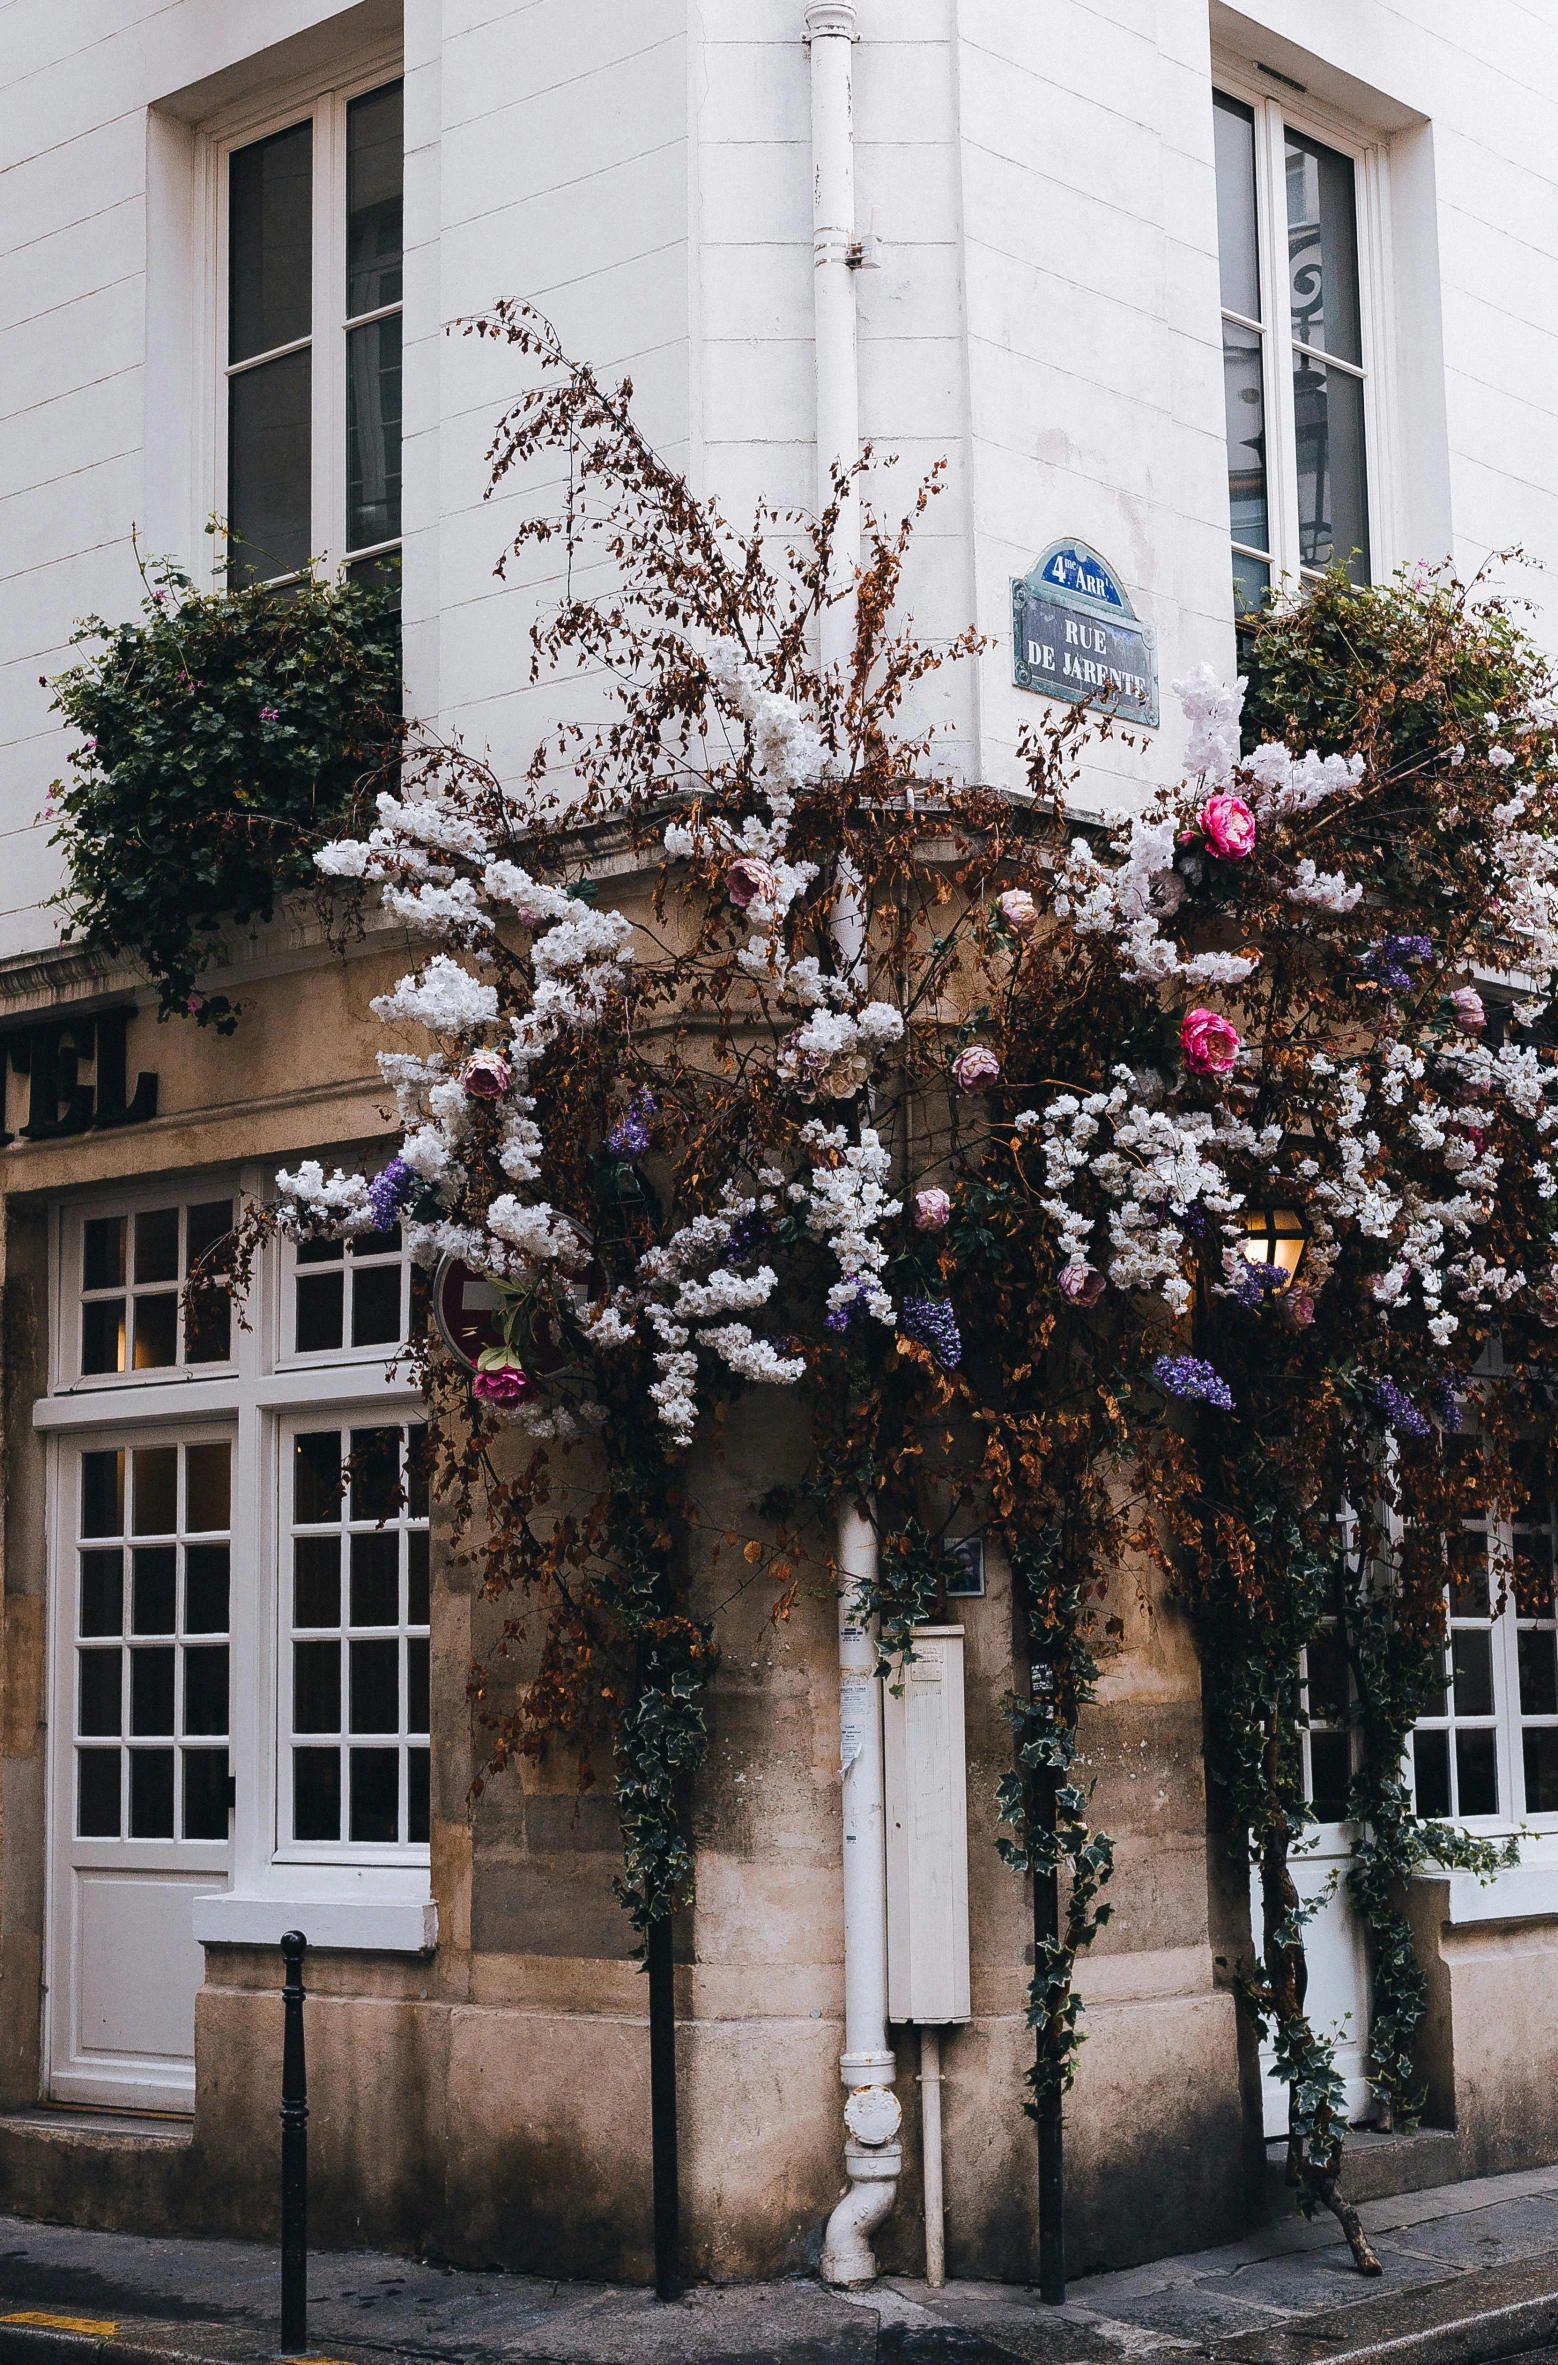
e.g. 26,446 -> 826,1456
50,1431 -> 234,2110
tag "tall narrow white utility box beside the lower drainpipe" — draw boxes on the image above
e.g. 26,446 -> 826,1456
882,1627 -> 969,2027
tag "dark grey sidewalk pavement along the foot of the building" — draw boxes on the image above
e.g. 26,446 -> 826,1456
0,2169 -> 1558,2365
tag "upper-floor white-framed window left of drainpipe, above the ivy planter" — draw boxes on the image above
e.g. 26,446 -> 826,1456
228,83 -> 404,582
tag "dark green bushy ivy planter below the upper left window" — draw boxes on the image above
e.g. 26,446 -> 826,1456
47,541 -> 402,1034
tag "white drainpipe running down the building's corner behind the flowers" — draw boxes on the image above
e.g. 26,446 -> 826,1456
806,0 -> 903,2285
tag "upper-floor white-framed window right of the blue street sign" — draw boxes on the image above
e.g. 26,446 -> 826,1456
1213,73 -> 1388,617
